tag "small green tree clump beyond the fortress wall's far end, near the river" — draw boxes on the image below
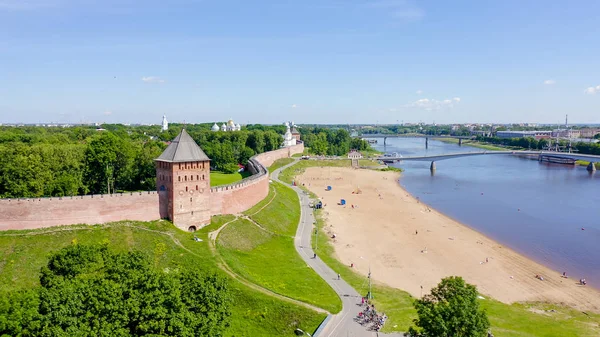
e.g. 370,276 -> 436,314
300,126 -> 369,156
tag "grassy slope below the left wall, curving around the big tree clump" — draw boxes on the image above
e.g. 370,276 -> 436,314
0,216 -> 325,336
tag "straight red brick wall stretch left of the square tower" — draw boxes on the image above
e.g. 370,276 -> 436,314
0,191 -> 160,230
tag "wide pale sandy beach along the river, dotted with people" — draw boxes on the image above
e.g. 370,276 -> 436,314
297,167 -> 600,312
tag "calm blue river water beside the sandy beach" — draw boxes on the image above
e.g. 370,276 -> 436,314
375,138 -> 600,288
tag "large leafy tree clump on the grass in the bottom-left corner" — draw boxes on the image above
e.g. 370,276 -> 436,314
0,244 -> 230,337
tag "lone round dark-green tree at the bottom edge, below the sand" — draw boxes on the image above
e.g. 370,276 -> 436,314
405,276 -> 490,337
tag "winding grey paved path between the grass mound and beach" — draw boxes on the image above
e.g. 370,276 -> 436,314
270,160 -> 403,337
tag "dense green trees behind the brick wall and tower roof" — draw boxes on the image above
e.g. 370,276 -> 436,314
0,124 -> 285,198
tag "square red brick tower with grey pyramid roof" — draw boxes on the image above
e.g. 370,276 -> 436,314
155,129 -> 210,231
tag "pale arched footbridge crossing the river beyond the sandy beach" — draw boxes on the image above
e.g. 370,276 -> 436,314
377,151 -> 600,171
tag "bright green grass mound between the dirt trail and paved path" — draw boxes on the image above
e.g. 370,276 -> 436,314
217,183 -> 341,313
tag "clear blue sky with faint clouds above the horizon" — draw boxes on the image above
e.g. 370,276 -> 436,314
0,0 -> 600,124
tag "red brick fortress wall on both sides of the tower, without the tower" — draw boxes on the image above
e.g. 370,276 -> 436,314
0,143 -> 304,230
